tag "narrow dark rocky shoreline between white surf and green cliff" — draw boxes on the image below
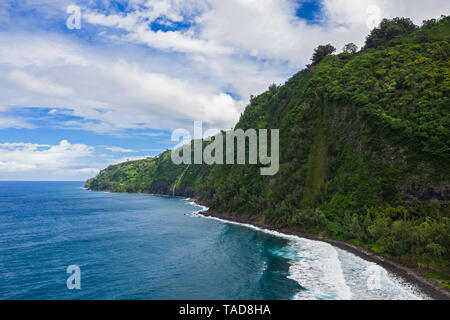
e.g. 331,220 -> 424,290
195,205 -> 450,300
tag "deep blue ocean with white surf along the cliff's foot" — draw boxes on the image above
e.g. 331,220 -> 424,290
0,181 -> 426,300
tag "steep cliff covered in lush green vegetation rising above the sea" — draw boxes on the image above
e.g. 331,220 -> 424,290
86,17 -> 450,271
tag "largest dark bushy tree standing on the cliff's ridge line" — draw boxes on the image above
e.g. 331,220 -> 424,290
365,18 -> 417,48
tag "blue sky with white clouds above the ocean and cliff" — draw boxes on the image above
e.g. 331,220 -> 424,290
0,0 -> 450,180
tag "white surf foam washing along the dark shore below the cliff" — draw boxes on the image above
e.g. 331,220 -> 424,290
185,201 -> 428,300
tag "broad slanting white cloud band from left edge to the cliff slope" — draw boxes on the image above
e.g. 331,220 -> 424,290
0,34 -> 243,133
